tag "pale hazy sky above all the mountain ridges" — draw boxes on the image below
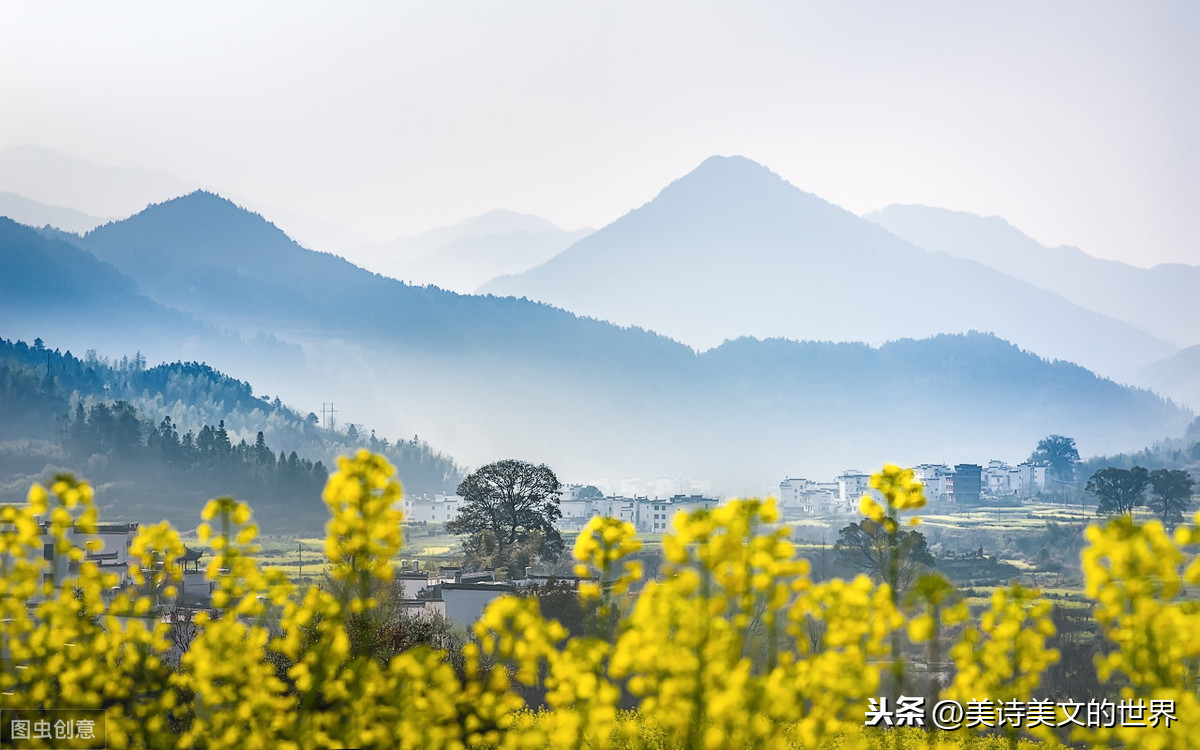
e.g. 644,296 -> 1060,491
0,0 -> 1200,265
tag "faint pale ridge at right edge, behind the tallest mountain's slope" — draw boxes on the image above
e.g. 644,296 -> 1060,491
864,205 -> 1200,347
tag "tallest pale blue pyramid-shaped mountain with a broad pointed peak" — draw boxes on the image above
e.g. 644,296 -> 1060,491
481,156 -> 1174,374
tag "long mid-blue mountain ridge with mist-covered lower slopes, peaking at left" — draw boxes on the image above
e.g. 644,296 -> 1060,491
7,193 -> 1192,493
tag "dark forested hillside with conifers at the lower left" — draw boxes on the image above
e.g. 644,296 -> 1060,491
0,340 -> 460,533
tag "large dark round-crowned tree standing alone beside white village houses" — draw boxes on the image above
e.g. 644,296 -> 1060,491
446,458 -> 563,564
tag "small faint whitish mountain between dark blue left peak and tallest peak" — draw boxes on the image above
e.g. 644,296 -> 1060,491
344,210 -> 592,294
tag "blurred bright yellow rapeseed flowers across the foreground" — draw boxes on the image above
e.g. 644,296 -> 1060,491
0,451 -> 1200,749
